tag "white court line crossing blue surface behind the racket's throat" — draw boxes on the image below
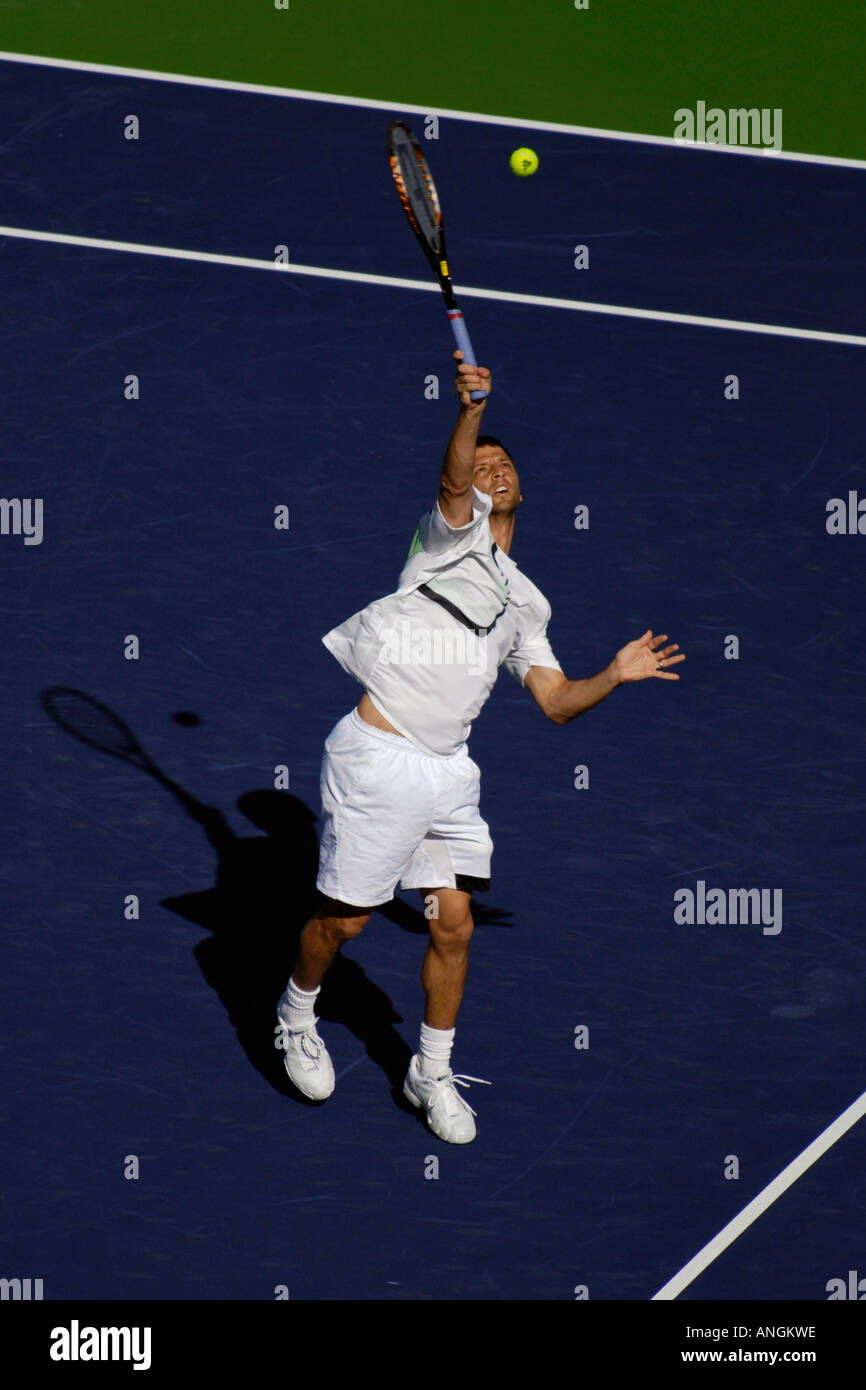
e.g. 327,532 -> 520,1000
0,227 -> 866,348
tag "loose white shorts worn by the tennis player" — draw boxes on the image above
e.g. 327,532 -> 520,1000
316,709 -> 493,908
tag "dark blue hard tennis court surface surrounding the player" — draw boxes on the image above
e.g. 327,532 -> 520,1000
0,48 -> 866,1301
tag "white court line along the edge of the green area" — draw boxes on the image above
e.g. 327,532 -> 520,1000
0,50 -> 866,170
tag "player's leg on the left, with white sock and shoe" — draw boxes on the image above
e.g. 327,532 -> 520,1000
274,898 -> 370,1101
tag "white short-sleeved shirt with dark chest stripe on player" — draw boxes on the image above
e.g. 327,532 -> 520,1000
322,488 -> 562,758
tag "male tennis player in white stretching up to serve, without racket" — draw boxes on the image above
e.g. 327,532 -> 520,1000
275,352 -> 685,1144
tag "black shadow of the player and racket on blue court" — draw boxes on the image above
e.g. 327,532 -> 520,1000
42,685 -> 414,1105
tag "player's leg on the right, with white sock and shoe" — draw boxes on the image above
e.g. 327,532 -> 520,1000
403,888 -> 489,1144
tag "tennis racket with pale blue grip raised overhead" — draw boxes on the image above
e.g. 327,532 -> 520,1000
388,121 -> 487,400
